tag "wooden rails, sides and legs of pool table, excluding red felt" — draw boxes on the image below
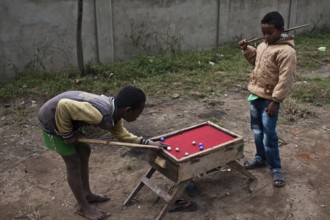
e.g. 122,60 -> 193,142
123,121 -> 256,220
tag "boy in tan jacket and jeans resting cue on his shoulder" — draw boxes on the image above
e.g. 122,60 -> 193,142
239,11 -> 296,187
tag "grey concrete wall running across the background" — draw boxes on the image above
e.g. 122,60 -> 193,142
0,0 -> 330,81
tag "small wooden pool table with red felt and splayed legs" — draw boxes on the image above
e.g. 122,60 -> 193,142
123,121 -> 255,220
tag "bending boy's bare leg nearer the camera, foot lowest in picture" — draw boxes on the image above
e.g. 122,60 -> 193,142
62,154 -> 108,220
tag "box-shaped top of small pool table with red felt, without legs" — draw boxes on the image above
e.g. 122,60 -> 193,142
149,121 -> 244,182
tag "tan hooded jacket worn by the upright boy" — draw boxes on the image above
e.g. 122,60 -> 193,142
243,35 -> 297,102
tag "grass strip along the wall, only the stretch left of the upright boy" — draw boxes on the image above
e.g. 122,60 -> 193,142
0,43 -> 248,102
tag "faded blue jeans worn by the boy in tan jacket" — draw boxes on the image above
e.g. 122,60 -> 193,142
250,98 -> 281,172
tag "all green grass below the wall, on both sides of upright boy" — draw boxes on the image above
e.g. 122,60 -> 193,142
0,32 -> 330,108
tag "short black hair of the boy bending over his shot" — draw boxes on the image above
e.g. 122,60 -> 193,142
115,86 -> 146,109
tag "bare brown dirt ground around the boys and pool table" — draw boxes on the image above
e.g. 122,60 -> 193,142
0,68 -> 330,220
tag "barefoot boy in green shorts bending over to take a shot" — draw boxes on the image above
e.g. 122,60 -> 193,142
38,86 -> 160,220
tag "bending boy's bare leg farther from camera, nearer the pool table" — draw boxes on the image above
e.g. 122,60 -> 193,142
76,147 -> 110,203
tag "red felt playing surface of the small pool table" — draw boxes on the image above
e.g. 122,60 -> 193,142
163,125 -> 235,159
